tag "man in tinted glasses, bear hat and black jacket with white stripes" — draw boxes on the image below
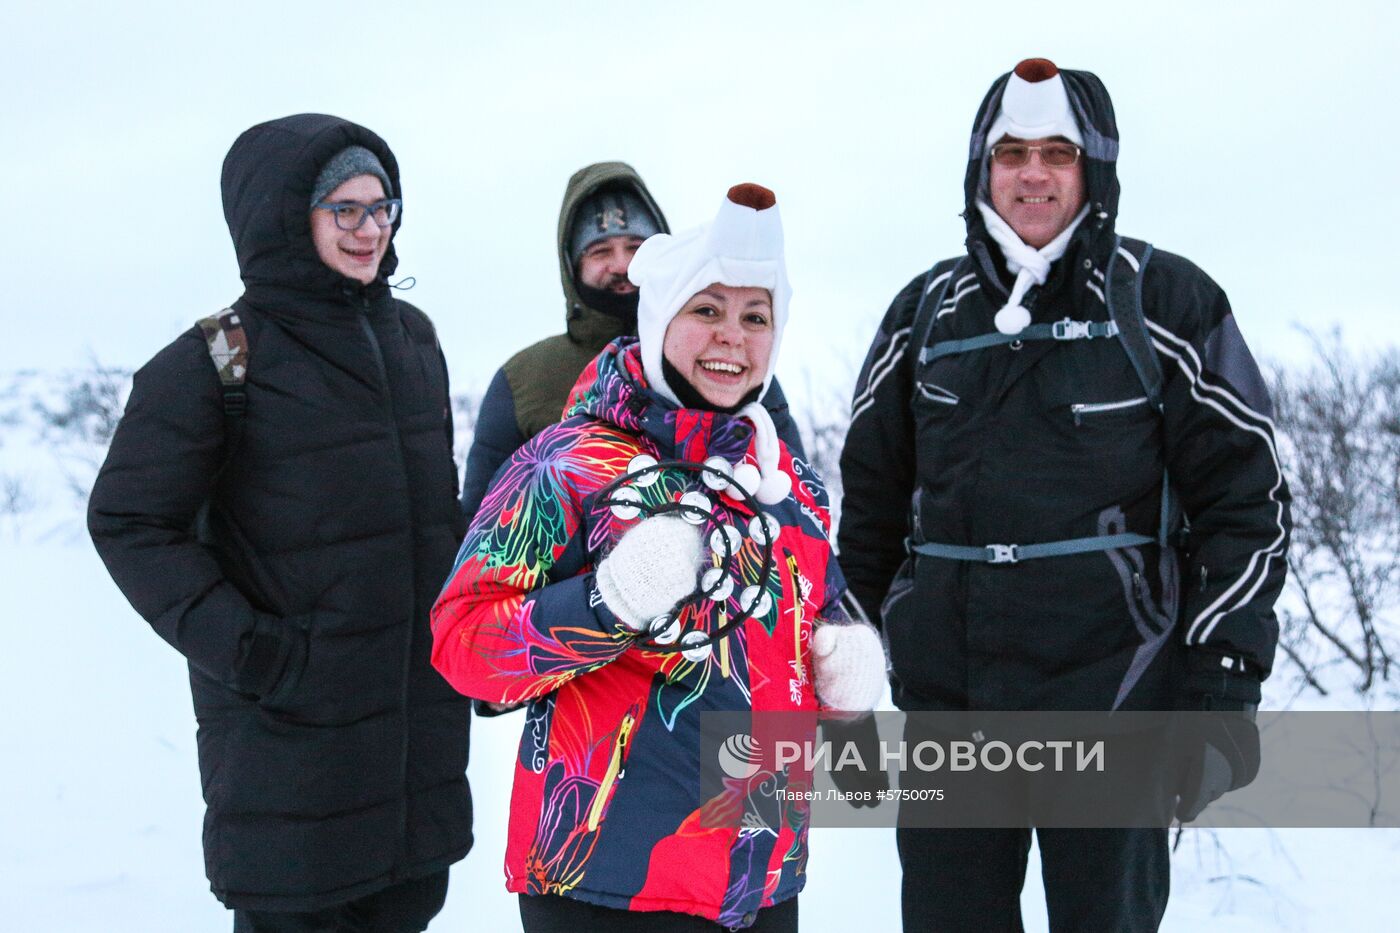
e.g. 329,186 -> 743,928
839,59 -> 1289,930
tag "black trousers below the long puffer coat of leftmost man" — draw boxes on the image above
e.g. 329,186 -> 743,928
234,870 -> 447,933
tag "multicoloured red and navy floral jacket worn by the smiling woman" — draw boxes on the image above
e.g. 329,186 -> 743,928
433,338 -> 846,927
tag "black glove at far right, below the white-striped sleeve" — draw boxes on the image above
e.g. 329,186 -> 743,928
1176,650 -> 1260,822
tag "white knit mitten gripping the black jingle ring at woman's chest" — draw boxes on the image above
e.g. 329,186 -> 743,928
596,516 -> 700,632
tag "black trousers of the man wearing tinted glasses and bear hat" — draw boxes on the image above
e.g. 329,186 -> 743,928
896,716 -> 1176,933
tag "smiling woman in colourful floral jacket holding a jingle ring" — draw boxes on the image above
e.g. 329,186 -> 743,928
433,185 -> 885,933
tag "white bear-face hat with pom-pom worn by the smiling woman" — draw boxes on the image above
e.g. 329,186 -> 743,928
627,184 -> 792,504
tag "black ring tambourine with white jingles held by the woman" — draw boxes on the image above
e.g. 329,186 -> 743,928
594,454 -> 783,663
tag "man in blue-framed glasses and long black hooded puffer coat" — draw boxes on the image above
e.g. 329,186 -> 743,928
88,113 -> 472,932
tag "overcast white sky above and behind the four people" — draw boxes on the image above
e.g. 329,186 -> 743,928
0,0 -> 1400,388
